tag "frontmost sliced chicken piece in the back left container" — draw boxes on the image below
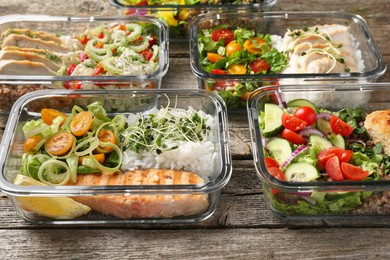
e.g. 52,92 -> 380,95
0,60 -> 56,76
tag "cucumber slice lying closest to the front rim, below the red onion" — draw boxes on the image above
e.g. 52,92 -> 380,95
284,163 -> 320,182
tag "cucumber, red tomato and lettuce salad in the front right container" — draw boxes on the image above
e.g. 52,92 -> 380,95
259,99 -> 390,215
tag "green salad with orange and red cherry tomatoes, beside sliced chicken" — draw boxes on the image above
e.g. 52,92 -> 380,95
198,25 -> 287,108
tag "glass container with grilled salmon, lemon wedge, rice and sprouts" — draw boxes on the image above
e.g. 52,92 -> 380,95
0,90 -> 232,224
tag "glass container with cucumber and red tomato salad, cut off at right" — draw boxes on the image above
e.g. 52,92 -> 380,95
247,83 -> 390,220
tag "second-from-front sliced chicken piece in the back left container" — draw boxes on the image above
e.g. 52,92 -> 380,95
0,50 -> 60,71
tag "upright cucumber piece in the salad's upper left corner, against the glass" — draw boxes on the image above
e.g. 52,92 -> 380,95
263,103 -> 283,137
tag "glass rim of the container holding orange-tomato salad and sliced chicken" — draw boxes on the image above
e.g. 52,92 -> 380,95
189,11 -> 387,82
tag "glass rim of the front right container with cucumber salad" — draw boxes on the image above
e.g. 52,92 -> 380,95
247,82 -> 390,192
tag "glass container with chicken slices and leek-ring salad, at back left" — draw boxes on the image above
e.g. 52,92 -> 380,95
0,15 -> 168,113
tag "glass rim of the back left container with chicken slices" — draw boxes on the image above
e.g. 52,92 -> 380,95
0,14 -> 169,84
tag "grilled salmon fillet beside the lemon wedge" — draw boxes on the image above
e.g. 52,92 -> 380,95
70,169 -> 209,218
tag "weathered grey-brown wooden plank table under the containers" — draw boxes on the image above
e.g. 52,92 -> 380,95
0,0 -> 390,259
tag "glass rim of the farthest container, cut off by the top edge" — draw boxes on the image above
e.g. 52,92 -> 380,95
109,0 -> 277,12
